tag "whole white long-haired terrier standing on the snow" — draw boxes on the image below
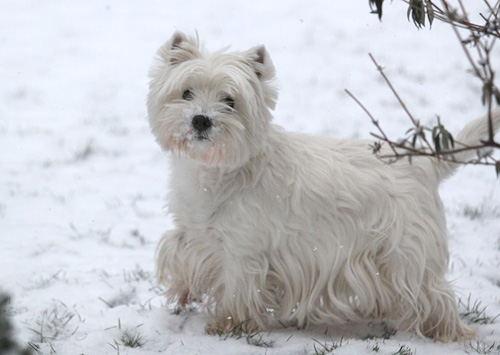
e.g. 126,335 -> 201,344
148,32 -> 500,341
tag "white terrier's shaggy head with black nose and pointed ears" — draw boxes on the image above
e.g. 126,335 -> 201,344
148,32 -> 278,167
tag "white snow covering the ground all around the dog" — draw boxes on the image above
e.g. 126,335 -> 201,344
0,0 -> 500,355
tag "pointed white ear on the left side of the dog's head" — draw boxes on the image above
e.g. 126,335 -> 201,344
158,31 -> 200,65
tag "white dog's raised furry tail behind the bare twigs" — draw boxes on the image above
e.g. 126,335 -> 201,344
434,108 -> 500,181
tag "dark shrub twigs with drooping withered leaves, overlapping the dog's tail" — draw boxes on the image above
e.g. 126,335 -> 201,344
360,0 -> 500,175
